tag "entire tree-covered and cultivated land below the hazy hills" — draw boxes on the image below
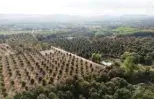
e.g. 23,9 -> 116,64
0,17 -> 154,99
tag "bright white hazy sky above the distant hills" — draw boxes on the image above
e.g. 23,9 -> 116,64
0,0 -> 154,16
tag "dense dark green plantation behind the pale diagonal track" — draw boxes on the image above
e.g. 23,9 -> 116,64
51,37 -> 154,65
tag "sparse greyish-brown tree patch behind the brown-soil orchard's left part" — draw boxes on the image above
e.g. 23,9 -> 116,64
5,33 -> 50,53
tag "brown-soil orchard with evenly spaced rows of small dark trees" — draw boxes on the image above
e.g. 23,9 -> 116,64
1,48 -> 103,97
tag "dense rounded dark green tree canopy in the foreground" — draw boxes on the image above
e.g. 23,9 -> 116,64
14,64 -> 153,99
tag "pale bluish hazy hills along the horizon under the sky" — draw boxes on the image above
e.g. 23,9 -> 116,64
0,14 -> 154,24
